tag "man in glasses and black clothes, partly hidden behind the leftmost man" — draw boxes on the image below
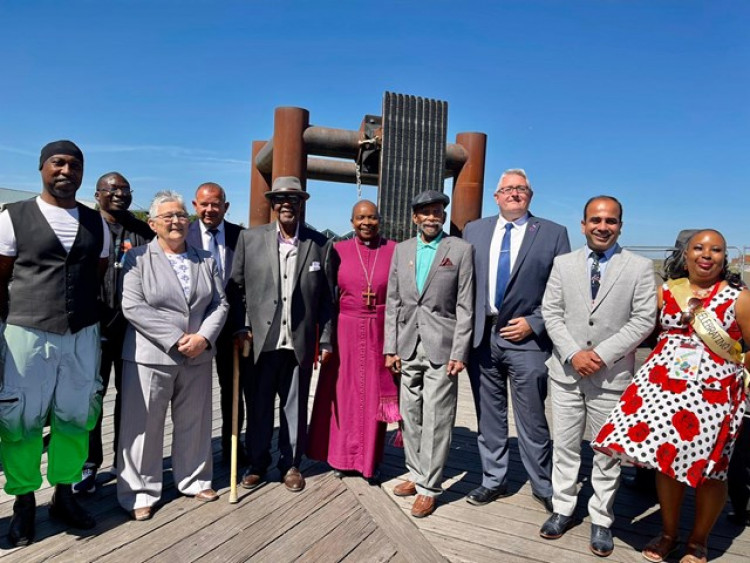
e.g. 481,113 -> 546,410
73,172 -> 154,493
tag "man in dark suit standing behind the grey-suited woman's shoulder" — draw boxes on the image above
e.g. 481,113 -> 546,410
187,182 -> 249,465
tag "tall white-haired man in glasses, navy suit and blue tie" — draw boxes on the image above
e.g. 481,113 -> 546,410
464,169 -> 570,512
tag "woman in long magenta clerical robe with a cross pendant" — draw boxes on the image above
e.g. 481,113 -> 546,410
308,201 -> 400,480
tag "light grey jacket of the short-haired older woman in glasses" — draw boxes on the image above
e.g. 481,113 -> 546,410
122,239 -> 229,365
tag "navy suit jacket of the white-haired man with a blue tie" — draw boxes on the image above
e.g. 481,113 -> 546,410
463,214 -> 570,351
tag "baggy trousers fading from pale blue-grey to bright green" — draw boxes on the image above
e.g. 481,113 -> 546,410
0,325 -> 102,495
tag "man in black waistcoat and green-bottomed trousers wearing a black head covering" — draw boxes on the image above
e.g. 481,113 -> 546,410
0,141 -> 110,547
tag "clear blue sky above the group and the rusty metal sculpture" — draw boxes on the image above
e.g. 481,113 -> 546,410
0,0 -> 750,251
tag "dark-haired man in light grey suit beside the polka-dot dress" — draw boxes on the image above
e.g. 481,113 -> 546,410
539,196 -> 656,557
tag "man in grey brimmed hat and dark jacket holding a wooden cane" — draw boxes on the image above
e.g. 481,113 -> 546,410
230,176 -> 333,492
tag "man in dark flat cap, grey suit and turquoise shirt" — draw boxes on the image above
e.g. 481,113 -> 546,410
383,190 -> 474,518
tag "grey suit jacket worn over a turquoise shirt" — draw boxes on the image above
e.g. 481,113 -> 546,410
383,236 -> 474,365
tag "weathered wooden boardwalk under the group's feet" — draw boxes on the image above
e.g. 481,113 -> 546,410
0,362 -> 750,563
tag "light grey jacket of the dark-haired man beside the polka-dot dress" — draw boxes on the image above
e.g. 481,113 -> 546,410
542,246 -> 656,390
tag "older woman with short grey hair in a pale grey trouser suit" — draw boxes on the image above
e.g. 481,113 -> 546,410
117,191 -> 228,520
